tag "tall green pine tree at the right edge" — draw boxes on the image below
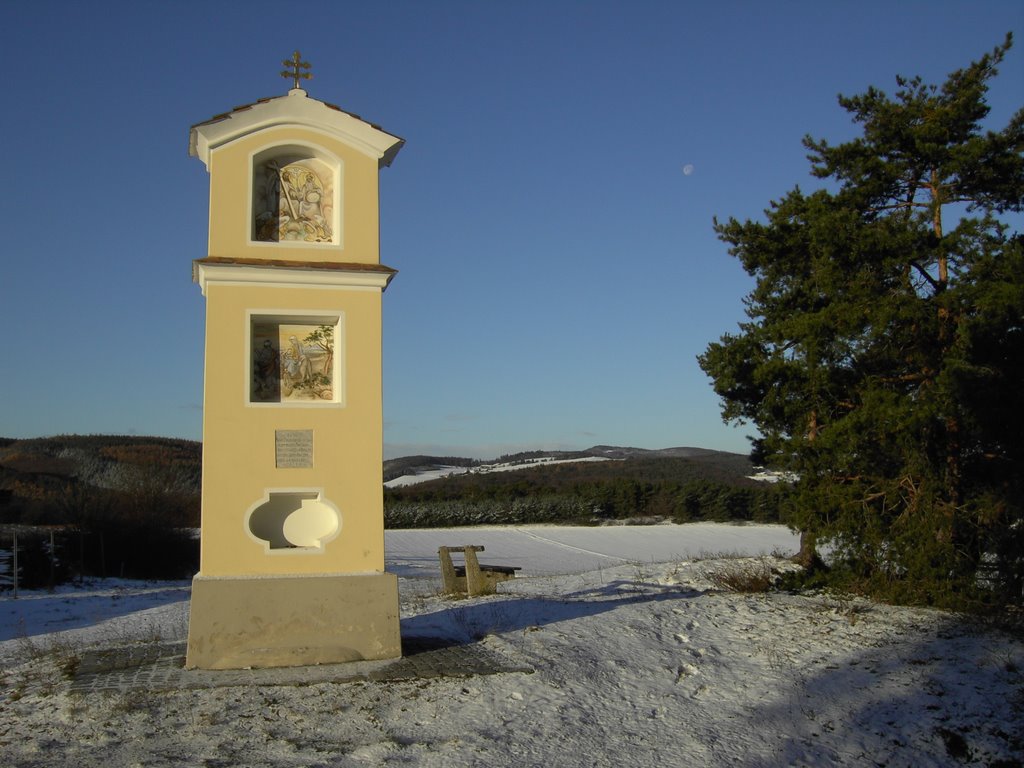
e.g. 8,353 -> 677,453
698,35 -> 1024,604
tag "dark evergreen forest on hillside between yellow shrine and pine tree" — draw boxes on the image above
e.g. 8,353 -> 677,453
384,454 -> 786,528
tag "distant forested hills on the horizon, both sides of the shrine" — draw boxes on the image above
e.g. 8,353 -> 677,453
0,435 -> 785,529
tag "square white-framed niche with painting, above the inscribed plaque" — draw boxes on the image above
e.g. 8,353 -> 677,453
245,309 -> 345,408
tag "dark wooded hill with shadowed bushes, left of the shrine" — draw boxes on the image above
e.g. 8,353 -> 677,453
0,435 -> 202,588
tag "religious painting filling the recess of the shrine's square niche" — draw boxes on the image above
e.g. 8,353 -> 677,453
249,323 -> 337,402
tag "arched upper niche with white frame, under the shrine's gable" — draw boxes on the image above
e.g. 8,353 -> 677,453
249,143 -> 343,247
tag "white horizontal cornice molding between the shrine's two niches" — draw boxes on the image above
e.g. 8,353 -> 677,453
193,260 -> 395,296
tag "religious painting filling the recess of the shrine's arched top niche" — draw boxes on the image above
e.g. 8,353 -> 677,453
253,160 -> 334,243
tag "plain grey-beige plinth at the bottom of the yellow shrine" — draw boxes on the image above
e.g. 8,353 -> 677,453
185,573 -> 401,670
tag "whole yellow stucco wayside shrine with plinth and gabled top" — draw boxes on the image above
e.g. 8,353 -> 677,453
186,78 -> 402,669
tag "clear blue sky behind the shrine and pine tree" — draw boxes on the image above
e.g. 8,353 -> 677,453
0,0 -> 1024,458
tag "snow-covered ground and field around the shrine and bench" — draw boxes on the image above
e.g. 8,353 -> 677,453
0,524 -> 1024,768
